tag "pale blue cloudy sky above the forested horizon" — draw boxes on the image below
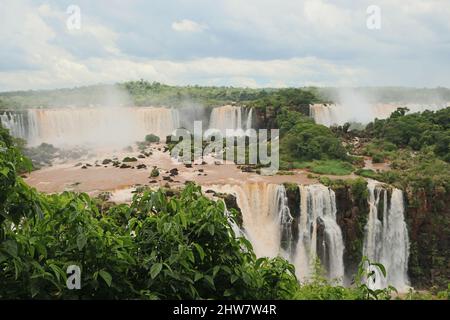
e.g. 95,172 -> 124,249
0,0 -> 450,91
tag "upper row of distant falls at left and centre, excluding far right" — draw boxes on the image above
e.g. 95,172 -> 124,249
0,106 -> 252,146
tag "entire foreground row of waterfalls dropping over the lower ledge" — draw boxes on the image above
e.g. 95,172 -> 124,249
205,181 -> 409,290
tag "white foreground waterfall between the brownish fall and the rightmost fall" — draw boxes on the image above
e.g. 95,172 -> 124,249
294,185 -> 344,281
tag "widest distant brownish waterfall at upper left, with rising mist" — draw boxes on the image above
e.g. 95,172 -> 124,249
1,107 -> 180,146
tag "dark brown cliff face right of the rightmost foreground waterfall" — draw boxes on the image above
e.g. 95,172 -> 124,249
406,189 -> 450,289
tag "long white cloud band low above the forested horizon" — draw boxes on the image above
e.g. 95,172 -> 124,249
0,57 -> 365,90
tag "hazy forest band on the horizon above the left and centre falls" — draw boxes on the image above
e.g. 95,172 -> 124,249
0,80 -> 318,110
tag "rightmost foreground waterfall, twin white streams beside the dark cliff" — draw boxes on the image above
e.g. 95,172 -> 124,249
363,181 -> 409,290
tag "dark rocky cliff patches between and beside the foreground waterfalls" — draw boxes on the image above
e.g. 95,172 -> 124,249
217,183 -> 450,289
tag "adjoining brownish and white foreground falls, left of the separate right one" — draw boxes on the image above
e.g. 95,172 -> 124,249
207,183 -> 344,280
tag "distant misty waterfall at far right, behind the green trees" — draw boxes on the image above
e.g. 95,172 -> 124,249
309,103 -> 448,127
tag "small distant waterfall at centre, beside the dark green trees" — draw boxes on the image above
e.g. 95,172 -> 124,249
209,105 -> 253,136
